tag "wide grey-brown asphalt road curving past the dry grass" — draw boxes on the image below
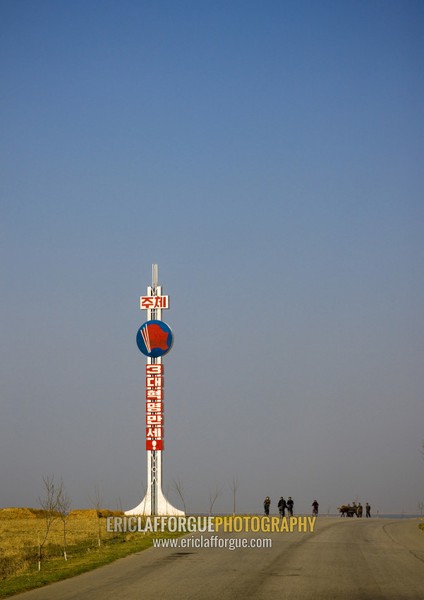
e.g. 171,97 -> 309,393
9,517 -> 424,600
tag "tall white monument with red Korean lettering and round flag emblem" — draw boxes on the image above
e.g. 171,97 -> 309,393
125,264 -> 184,515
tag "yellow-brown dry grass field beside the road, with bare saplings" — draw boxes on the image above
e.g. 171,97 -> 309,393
0,508 -> 181,598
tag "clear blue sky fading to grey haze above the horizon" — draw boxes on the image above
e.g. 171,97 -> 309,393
0,0 -> 424,512
